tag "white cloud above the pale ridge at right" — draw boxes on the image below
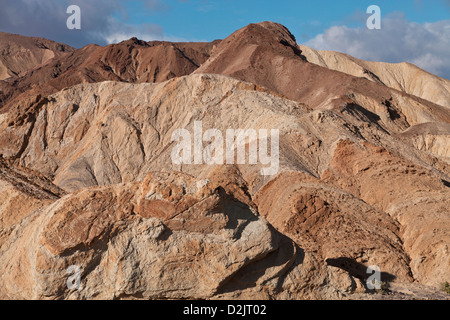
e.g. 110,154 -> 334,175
305,13 -> 450,79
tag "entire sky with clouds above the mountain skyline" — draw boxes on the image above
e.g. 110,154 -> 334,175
0,0 -> 450,79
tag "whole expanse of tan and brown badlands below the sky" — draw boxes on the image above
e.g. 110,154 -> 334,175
0,22 -> 450,299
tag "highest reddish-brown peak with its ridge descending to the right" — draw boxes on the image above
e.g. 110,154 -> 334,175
195,22 -> 450,133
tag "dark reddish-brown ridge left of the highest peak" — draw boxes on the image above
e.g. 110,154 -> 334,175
0,38 -> 216,114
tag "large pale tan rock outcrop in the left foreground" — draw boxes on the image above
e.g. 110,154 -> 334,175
0,173 -> 338,299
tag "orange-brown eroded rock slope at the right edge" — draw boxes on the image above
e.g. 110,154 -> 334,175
322,141 -> 450,286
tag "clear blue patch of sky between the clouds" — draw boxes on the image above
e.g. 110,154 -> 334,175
121,0 -> 450,43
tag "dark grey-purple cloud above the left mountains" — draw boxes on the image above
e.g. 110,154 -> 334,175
0,0 -> 182,47
